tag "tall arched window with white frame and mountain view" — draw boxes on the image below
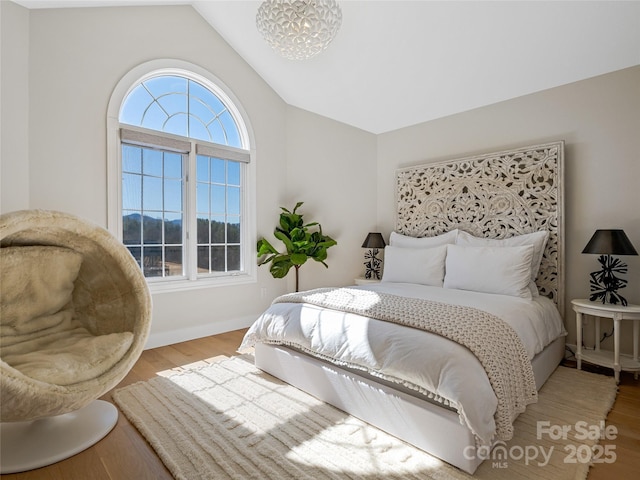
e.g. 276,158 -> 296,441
110,63 -> 255,288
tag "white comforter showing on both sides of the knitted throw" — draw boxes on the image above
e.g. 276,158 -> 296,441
240,283 -> 566,445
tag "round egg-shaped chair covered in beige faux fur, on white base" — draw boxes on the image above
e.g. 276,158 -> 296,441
0,210 -> 151,473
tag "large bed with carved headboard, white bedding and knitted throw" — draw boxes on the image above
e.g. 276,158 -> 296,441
241,141 -> 566,474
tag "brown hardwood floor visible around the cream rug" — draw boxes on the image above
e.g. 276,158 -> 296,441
0,330 -> 640,480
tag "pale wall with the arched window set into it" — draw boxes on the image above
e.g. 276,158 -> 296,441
23,6 -> 286,345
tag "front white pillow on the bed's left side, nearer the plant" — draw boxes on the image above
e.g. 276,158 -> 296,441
382,245 -> 447,287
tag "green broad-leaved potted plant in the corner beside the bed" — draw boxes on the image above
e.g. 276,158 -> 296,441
257,202 -> 337,292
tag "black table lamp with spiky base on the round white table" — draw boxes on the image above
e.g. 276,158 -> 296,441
582,230 -> 638,306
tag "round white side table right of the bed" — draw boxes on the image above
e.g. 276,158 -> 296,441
571,299 -> 640,383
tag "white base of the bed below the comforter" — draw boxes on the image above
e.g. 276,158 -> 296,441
255,337 -> 565,474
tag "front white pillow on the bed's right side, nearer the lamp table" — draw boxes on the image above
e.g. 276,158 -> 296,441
444,245 -> 534,300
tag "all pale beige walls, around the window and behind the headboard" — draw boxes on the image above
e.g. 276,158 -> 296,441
0,2 -> 640,352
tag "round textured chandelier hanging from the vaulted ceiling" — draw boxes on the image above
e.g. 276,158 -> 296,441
256,0 -> 342,60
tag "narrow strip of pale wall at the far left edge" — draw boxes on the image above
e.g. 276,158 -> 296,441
0,1 -> 29,212
